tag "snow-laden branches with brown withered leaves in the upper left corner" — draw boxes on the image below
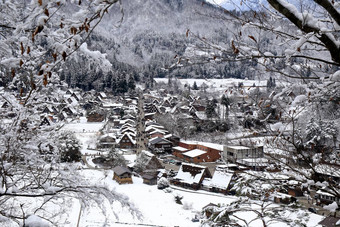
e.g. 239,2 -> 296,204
0,0 -> 118,90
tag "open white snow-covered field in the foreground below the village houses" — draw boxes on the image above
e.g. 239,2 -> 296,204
75,170 -> 234,226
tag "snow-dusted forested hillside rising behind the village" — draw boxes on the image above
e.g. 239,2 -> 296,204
61,0 -> 282,93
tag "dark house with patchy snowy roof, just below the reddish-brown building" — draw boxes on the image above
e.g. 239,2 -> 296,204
171,163 -> 212,190
